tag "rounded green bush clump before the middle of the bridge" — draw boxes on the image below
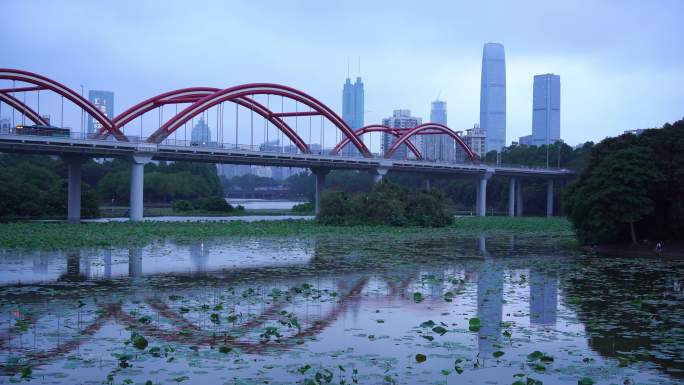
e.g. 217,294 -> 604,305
318,180 -> 453,227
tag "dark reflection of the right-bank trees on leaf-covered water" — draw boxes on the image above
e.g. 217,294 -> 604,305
561,257 -> 684,378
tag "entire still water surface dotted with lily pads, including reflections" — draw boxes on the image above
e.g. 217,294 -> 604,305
0,234 -> 684,384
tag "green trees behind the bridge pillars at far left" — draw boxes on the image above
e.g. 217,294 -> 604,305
0,154 -> 223,218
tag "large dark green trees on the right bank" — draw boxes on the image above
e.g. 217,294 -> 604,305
566,120 -> 684,243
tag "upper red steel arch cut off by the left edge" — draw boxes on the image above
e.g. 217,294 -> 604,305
0,68 -> 128,141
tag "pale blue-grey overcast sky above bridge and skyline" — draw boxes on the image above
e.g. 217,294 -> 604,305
0,0 -> 684,144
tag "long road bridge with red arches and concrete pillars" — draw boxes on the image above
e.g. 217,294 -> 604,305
0,68 -> 574,221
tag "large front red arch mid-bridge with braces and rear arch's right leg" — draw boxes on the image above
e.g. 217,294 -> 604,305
147,83 -> 372,157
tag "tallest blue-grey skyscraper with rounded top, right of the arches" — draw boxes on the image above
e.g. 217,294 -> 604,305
480,43 -> 506,151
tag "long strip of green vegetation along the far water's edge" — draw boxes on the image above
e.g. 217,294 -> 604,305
0,217 -> 573,249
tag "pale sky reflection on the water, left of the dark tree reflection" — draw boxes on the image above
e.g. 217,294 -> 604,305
0,236 -> 681,384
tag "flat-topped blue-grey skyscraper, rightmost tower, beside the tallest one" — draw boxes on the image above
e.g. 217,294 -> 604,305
532,74 -> 560,146
